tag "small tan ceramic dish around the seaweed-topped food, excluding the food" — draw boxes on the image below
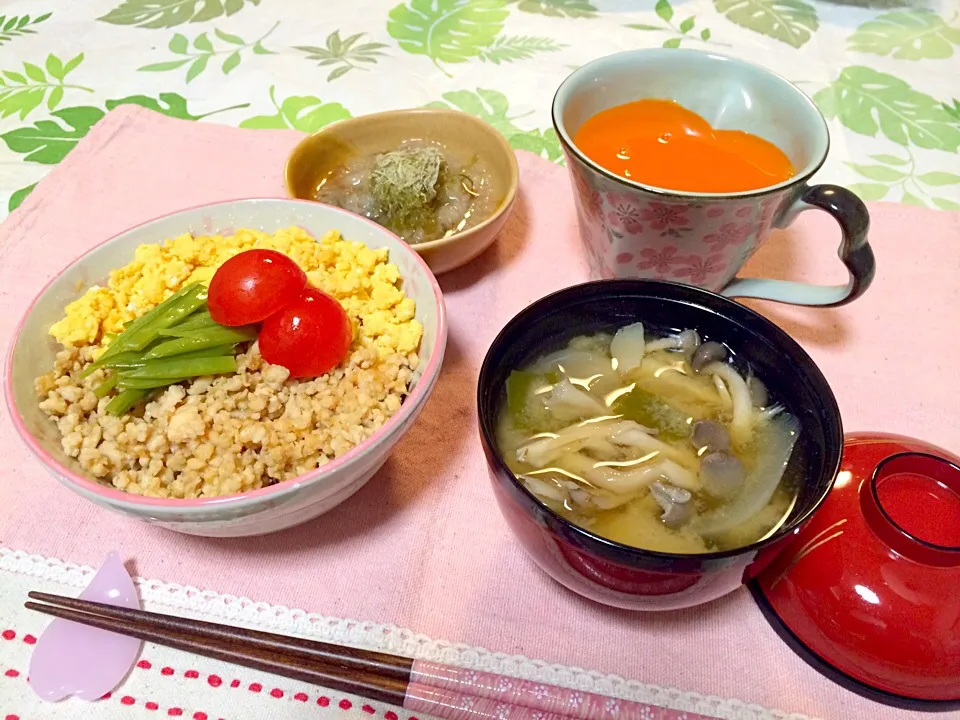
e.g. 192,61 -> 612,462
285,108 -> 520,275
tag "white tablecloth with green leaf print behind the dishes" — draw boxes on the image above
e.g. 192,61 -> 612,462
0,0 -> 960,210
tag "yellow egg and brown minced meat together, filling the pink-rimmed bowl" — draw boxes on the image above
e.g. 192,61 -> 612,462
36,228 -> 423,498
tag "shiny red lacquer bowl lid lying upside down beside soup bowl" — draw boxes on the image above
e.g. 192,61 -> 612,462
752,433 -> 960,710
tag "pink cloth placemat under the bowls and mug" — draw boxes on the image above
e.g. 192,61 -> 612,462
0,107 -> 960,720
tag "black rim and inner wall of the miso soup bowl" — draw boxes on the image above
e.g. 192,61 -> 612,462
476,278 -> 843,570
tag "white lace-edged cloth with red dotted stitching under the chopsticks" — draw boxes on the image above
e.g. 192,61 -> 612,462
0,547 -> 811,720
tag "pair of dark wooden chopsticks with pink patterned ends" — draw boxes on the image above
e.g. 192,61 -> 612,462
24,592 -> 724,720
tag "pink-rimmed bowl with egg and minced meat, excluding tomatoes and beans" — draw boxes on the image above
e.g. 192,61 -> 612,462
5,199 -> 447,537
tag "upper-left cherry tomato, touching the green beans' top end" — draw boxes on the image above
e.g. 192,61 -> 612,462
207,250 -> 307,326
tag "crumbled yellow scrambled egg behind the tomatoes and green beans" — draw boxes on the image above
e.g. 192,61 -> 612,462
50,227 -> 423,358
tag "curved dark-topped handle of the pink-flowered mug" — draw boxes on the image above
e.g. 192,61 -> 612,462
721,185 -> 876,307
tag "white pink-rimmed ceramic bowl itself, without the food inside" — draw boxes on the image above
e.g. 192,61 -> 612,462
4,199 -> 447,537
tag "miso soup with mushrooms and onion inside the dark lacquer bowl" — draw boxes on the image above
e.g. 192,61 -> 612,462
497,323 -> 800,554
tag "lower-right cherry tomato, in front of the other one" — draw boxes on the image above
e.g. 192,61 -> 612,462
260,287 -> 353,378
